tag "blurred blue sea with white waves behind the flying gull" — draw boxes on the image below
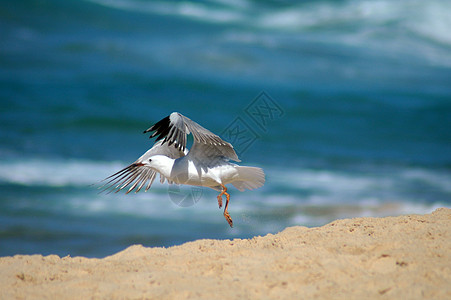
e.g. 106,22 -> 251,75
0,0 -> 451,257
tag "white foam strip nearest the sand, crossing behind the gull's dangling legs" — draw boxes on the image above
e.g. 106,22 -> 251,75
47,185 -> 446,230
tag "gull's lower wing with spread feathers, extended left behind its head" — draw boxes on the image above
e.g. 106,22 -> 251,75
100,141 -> 185,194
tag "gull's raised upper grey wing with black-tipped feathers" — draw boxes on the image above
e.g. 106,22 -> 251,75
144,112 -> 240,161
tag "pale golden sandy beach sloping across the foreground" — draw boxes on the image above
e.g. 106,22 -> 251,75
0,208 -> 451,299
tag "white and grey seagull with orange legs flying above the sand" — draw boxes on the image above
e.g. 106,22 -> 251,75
100,112 -> 265,227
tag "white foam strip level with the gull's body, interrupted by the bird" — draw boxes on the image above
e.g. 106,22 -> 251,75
0,158 -> 451,198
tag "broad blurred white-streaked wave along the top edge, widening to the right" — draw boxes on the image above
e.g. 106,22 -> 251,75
83,0 -> 451,66
